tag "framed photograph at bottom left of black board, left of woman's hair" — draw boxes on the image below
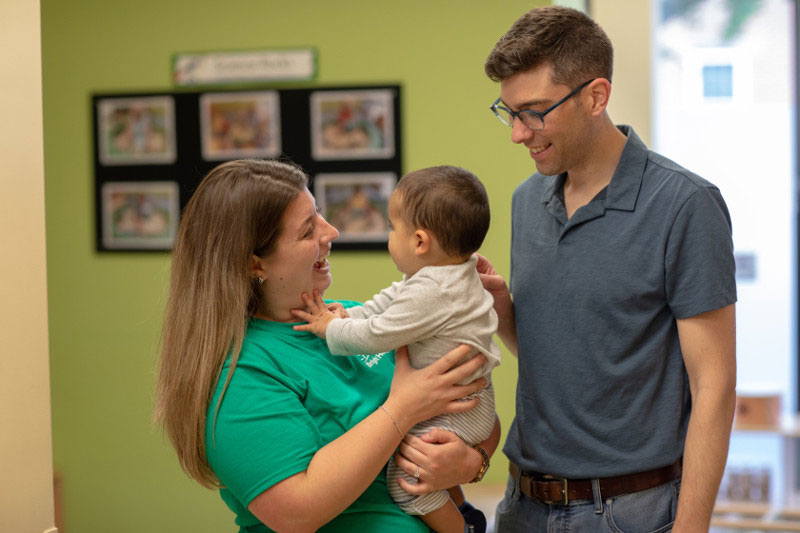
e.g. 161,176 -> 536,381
101,181 -> 180,250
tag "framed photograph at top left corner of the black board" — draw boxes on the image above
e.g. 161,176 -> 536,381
97,96 -> 175,165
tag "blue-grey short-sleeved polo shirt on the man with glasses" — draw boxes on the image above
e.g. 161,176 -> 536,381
503,126 -> 736,478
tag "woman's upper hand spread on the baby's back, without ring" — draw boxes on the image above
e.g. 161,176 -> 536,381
384,344 -> 486,432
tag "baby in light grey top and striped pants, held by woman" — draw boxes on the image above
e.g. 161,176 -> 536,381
293,166 -> 500,532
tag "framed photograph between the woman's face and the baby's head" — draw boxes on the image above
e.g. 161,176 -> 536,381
314,172 -> 397,243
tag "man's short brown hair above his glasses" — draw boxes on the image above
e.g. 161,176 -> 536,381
484,6 -> 614,87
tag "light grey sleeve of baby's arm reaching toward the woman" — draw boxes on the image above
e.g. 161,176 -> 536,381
325,275 -> 450,355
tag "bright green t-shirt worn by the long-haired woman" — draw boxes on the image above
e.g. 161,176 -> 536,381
206,302 -> 428,533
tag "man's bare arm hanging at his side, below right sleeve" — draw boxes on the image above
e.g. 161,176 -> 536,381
673,304 -> 736,532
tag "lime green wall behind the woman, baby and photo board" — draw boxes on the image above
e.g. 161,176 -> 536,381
42,0 -> 546,533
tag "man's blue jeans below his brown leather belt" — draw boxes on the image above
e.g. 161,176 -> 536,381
494,470 -> 681,533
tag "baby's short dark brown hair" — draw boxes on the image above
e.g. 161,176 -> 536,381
395,165 -> 490,257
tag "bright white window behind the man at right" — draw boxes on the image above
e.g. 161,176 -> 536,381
651,0 -> 800,502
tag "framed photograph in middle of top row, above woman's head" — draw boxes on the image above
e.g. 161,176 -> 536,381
200,91 -> 281,161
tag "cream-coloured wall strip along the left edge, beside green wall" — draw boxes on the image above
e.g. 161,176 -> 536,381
0,0 -> 55,533
